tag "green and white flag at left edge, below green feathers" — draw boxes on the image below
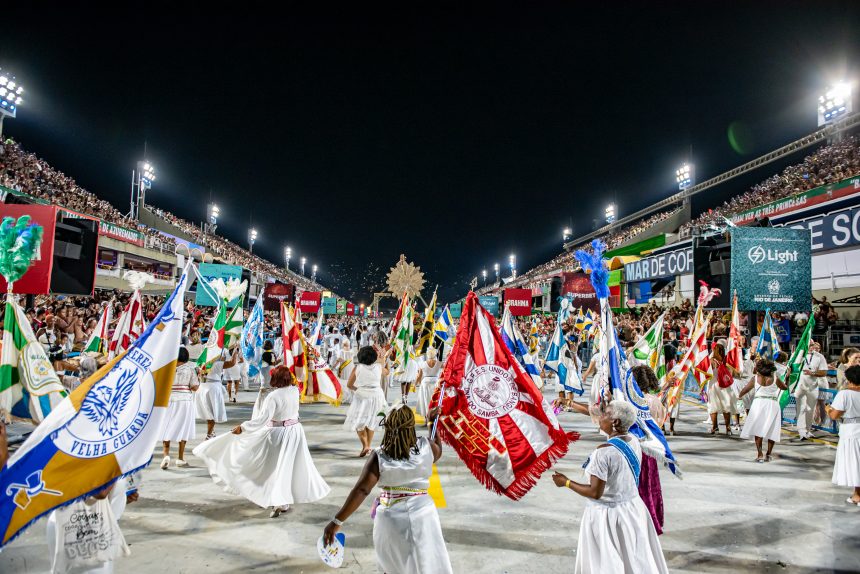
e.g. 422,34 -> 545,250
0,293 -> 68,424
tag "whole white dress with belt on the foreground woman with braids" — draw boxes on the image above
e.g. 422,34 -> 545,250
373,437 -> 453,574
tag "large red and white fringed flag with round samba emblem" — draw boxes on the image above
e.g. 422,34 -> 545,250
438,292 -> 579,500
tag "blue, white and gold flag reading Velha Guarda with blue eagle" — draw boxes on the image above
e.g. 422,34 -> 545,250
0,267 -> 189,545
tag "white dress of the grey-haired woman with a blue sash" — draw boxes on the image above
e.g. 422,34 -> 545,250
574,439 -> 669,574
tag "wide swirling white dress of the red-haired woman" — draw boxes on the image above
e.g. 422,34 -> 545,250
194,386 -> 330,508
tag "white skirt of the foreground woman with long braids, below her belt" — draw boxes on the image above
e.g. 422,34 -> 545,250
373,494 -> 453,574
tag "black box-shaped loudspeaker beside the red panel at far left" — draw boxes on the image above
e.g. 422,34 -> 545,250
51,217 -> 99,295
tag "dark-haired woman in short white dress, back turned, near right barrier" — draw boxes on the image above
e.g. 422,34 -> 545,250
740,359 -> 787,462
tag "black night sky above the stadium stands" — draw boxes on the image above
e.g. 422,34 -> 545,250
0,0 -> 860,301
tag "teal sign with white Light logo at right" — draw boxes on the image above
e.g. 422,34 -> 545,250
732,227 -> 812,311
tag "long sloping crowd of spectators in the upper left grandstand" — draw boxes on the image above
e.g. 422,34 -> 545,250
0,139 -> 322,290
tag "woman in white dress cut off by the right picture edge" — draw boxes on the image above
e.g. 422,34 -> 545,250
825,366 -> 860,506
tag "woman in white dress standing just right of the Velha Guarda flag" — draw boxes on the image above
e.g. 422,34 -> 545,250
161,347 -> 200,470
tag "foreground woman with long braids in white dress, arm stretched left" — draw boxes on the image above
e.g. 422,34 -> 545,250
323,405 -> 453,574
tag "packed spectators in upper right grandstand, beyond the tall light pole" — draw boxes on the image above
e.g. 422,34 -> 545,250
682,136 -> 860,234
